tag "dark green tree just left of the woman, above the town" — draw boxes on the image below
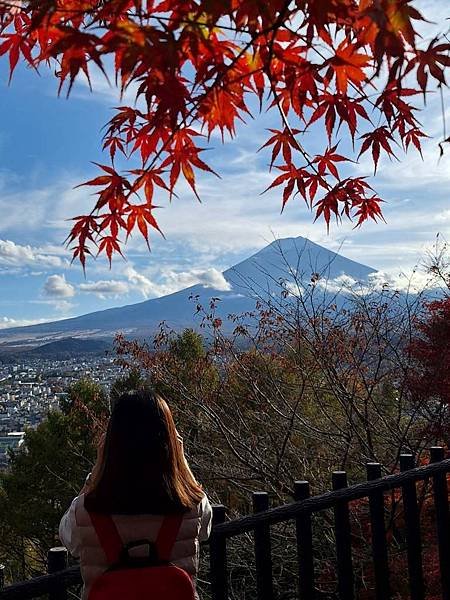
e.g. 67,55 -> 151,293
0,380 -> 107,581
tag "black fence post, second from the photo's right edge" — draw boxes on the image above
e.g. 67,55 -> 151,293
400,454 -> 425,600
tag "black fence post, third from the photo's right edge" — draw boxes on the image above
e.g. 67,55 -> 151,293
366,463 -> 391,600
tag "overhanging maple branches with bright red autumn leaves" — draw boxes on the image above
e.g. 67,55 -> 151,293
0,0 -> 450,266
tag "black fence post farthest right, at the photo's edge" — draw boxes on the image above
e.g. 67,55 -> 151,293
430,446 -> 450,600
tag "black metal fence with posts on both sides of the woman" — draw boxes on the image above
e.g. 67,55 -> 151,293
0,447 -> 450,600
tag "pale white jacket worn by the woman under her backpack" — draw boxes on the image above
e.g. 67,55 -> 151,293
59,494 -> 212,600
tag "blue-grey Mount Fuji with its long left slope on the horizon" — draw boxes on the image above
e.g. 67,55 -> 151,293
0,237 -> 376,348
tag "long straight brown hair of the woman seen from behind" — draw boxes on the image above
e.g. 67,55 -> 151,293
85,389 -> 203,514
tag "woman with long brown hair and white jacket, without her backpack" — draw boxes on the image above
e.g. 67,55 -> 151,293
59,390 -> 211,599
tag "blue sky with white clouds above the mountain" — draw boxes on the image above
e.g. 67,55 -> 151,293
0,0 -> 450,328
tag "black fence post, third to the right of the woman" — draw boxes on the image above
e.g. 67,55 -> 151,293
294,481 -> 314,600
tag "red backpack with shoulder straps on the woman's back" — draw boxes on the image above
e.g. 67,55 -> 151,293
89,513 -> 195,600
